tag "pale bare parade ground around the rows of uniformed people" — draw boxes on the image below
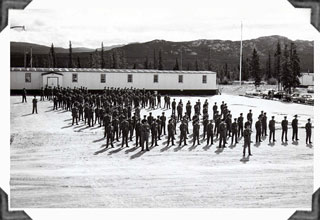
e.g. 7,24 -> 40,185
10,94 -> 314,208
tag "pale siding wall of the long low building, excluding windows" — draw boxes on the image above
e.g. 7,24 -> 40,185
11,71 -> 217,90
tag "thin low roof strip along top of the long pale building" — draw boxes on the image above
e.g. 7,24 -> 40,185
11,67 -> 216,74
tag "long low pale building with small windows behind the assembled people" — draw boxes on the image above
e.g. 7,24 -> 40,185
10,68 -> 218,95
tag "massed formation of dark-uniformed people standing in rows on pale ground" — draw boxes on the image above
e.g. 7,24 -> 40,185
23,87 -> 312,156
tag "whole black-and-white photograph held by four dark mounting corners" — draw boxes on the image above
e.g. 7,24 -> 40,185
1,0 -> 319,218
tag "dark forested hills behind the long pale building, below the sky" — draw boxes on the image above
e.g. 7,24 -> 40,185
11,36 -> 314,78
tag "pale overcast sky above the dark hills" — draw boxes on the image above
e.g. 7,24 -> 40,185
10,0 -> 317,48
